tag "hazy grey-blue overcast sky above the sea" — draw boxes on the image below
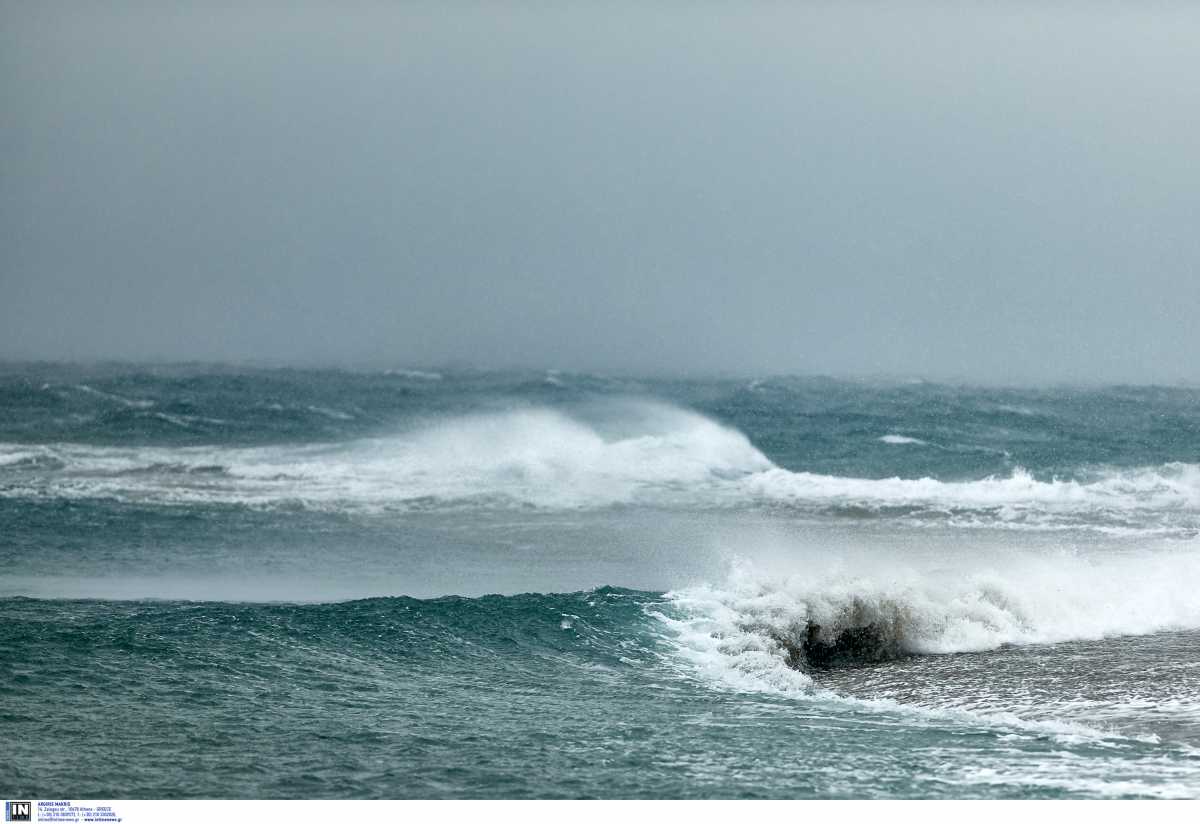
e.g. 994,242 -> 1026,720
0,0 -> 1200,381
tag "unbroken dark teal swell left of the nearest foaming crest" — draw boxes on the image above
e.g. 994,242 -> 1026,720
0,588 -> 661,669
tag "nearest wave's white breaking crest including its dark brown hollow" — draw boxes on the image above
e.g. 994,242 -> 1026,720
668,546 -> 1200,671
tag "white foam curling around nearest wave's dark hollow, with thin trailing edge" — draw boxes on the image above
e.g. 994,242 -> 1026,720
653,546 -> 1200,741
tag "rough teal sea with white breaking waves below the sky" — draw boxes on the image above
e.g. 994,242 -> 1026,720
0,362 -> 1200,799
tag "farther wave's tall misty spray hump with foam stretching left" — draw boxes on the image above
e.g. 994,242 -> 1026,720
0,403 -> 773,509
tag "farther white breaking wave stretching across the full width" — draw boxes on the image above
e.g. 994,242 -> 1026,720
0,401 -> 1200,534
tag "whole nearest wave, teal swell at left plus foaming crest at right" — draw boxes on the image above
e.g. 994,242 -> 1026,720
9,573 -> 1200,741
